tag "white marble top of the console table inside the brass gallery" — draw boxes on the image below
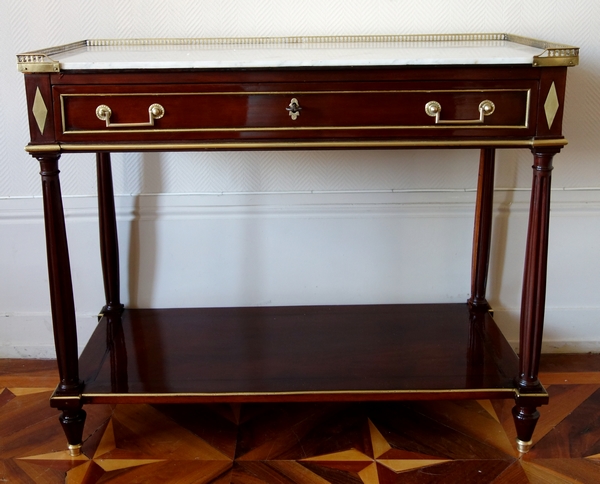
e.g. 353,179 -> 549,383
37,40 -> 544,71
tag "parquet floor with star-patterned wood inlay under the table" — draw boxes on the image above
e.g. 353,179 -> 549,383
0,355 -> 600,484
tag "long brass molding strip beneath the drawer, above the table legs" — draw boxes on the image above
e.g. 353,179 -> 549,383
25,138 -> 568,154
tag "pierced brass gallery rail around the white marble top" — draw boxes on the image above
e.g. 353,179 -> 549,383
17,33 -> 579,73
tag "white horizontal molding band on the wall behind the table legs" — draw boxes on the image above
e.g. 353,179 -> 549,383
0,188 -> 600,223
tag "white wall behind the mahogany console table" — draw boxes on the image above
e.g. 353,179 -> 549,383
0,0 -> 600,357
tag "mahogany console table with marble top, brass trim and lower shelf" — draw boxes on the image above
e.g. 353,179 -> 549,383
18,34 -> 579,455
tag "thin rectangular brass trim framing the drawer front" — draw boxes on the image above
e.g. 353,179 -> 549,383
60,88 -> 531,134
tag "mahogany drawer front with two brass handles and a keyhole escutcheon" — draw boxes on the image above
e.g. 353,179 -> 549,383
56,85 -> 533,141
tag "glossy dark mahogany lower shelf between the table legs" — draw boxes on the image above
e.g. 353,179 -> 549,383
80,304 -> 518,403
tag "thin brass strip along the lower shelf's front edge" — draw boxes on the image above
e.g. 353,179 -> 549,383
81,388 -> 516,398
